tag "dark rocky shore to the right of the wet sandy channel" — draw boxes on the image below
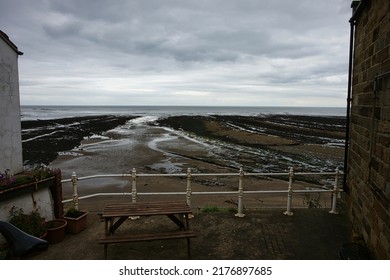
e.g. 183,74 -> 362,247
157,115 -> 345,172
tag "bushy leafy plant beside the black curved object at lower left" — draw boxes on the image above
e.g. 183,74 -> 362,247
9,206 -> 47,238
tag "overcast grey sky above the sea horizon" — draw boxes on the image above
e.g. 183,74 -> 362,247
0,0 -> 351,106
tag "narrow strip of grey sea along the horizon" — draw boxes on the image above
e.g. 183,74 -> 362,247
21,105 -> 346,121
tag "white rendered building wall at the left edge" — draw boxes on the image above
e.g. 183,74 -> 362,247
0,34 -> 23,174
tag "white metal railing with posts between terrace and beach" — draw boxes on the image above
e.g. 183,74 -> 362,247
61,168 -> 343,217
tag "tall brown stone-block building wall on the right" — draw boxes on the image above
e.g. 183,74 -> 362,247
347,0 -> 390,259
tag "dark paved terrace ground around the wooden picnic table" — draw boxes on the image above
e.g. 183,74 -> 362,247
29,200 -> 351,260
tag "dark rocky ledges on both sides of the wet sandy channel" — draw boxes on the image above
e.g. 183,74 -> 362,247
22,115 -> 345,172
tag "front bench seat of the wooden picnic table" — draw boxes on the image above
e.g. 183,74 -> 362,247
99,230 -> 196,259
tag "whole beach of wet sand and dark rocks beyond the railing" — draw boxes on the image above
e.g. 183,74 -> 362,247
22,112 -> 345,208
